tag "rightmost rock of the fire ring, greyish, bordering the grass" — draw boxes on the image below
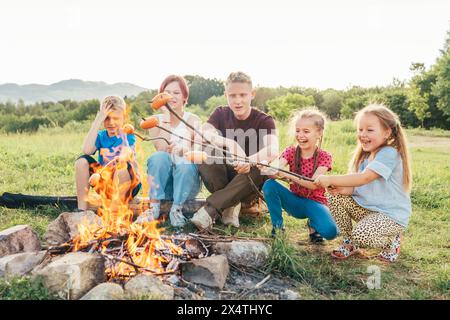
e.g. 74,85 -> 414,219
214,241 -> 269,268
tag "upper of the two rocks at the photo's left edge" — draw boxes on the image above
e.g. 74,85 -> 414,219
0,225 -> 41,258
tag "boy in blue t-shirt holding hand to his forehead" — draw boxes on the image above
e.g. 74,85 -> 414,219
75,96 -> 141,211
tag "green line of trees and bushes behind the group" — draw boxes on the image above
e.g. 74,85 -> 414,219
0,31 -> 450,133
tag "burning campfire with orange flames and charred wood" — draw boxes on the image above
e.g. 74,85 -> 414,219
45,134 -> 208,280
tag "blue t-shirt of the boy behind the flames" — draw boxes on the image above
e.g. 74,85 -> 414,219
95,130 -> 136,166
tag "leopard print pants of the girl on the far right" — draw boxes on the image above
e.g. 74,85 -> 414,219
328,194 -> 405,250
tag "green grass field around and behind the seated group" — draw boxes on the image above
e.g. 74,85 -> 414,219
0,121 -> 450,299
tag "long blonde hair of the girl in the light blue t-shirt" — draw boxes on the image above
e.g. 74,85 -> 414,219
349,104 -> 412,192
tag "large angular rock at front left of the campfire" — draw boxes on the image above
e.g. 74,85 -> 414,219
33,252 -> 106,299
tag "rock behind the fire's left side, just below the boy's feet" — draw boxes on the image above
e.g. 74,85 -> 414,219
44,211 -> 101,245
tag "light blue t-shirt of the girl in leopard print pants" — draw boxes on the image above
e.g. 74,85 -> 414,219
352,146 -> 412,227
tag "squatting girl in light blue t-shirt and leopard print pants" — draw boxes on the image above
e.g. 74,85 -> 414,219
315,104 -> 412,262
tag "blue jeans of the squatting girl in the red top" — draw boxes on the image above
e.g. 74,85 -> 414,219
263,179 -> 339,240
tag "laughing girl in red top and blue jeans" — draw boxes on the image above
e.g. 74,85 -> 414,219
263,108 -> 338,242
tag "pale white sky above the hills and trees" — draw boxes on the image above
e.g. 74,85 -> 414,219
0,0 -> 450,89
